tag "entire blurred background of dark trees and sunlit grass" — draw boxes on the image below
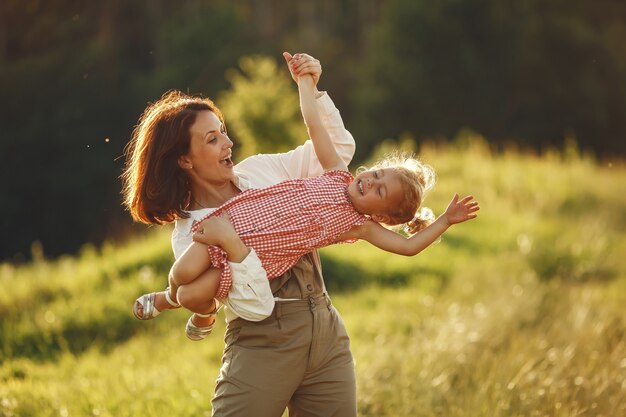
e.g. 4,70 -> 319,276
0,0 -> 626,417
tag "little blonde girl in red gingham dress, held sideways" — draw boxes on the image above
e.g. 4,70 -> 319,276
163,64 -> 479,340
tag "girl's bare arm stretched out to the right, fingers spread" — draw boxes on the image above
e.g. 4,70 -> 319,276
338,194 -> 480,256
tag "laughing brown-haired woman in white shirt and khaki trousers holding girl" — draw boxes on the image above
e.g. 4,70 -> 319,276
123,53 -> 356,417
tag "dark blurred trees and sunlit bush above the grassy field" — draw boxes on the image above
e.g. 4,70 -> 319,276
0,0 -> 626,262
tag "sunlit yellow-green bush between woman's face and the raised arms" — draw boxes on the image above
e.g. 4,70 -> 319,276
218,56 -> 308,158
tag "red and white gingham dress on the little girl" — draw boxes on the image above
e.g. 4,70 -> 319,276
192,171 -> 369,298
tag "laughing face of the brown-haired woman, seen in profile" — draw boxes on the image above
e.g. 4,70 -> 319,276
179,110 -> 234,184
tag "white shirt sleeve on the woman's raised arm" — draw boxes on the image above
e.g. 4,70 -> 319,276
235,93 -> 356,188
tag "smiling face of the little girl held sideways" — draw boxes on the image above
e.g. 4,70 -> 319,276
348,168 -> 404,223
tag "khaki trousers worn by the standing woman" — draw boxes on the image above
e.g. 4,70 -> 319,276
213,295 -> 356,417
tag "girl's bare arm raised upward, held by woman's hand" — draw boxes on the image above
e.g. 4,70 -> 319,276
298,75 -> 348,171
